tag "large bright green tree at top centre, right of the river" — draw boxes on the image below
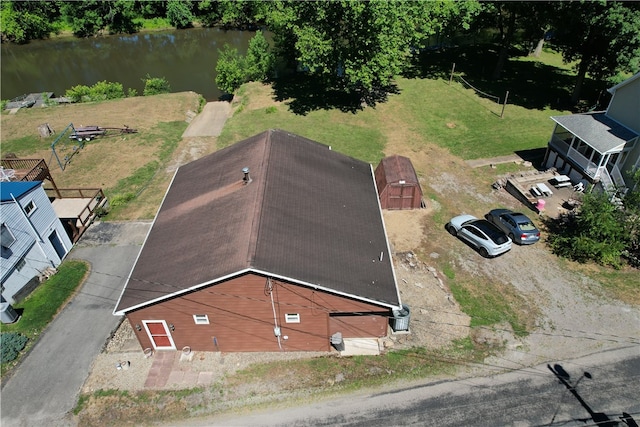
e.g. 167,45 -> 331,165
267,0 -> 478,98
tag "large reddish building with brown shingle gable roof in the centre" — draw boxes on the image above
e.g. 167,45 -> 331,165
114,130 -> 401,352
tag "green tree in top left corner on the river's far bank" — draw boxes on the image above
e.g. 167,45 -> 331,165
0,0 -> 60,43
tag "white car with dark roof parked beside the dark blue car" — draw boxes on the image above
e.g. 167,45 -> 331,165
445,215 -> 511,258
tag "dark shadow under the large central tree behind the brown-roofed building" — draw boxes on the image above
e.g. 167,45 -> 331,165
273,73 -> 400,116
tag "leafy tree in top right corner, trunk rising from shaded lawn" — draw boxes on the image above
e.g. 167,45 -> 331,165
554,1 -> 640,103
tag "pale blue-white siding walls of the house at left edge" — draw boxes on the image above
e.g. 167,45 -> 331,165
0,187 -> 72,302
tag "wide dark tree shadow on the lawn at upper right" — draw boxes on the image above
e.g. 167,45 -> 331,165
405,45 -> 608,111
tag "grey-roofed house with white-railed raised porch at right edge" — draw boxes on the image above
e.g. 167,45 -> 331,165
543,73 -> 640,194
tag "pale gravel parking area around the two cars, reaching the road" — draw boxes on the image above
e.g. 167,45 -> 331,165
429,173 -> 640,369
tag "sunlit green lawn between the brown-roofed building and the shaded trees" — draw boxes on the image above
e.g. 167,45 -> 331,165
218,50 -> 569,164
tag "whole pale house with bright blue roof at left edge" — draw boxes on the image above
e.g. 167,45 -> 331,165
0,181 -> 73,303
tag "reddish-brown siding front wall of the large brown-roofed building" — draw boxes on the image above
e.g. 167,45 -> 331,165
127,274 -> 387,352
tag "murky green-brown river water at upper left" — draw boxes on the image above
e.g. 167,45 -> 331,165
0,28 -> 255,101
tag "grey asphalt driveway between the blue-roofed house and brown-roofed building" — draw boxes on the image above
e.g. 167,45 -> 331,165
0,222 -> 151,427
